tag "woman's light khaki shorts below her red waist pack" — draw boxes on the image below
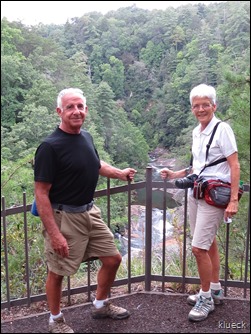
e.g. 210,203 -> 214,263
188,194 -> 225,250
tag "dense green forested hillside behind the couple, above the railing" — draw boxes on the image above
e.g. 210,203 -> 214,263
1,1 -> 250,205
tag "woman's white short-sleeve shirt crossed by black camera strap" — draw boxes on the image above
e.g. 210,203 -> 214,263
192,116 -> 237,182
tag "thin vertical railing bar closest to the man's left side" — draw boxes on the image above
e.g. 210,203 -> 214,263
23,192 -> 31,307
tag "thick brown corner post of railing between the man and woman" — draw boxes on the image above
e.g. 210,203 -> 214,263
145,167 -> 152,291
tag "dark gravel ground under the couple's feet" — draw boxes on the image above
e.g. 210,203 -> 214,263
1,292 -> 250,333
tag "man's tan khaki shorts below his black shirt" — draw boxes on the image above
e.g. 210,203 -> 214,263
43,205 -> 119,276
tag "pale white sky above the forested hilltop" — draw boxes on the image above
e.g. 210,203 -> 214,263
1,1 -> 226,25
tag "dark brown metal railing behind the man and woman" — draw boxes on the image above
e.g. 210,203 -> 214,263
1,167 -> 250,309
